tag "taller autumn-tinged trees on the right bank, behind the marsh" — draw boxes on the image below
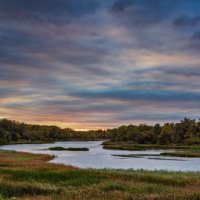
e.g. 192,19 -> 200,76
107,118 -> 200,145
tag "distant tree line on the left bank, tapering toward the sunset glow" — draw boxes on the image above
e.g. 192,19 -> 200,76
0,119 -> 106,144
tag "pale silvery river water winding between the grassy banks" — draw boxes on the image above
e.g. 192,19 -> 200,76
0,141 -> 200,171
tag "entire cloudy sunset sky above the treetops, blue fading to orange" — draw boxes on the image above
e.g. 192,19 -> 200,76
0,0 -> 200,130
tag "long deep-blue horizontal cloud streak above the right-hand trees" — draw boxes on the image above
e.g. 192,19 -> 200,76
70,88 -> 200,102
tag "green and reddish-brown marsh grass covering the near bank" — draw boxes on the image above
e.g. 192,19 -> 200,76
0,151 -> 200,200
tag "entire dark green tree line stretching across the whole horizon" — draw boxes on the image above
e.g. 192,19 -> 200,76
0,118 -> 200,144
